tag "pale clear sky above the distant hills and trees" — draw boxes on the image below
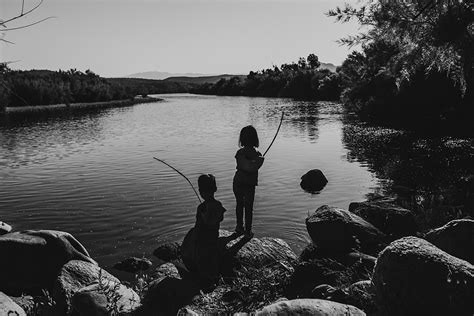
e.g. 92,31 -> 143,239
0,0 -> 358,77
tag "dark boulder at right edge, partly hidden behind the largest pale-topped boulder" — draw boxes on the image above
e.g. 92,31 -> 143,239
425,219 -> 474,264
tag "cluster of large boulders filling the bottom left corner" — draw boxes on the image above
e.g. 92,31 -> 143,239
0,230 -> 140,316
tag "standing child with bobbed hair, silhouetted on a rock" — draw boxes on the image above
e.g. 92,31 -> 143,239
233,125 -> 264,238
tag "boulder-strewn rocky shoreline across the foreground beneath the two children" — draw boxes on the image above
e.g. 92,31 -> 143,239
0,198 -> 474,316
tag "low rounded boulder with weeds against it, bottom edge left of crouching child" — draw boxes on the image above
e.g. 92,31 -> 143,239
72,282 -> 140,316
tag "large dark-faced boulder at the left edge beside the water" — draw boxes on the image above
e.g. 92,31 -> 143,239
0,230 -> 96,294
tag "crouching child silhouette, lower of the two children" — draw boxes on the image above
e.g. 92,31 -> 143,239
181,174 -> 226,288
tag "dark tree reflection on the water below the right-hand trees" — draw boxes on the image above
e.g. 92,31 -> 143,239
343,120 -> 474,229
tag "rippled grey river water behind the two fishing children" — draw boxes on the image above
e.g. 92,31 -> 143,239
0,94 -> 472,267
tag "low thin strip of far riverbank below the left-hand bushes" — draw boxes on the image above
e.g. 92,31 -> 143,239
4,97 -> 163,114
